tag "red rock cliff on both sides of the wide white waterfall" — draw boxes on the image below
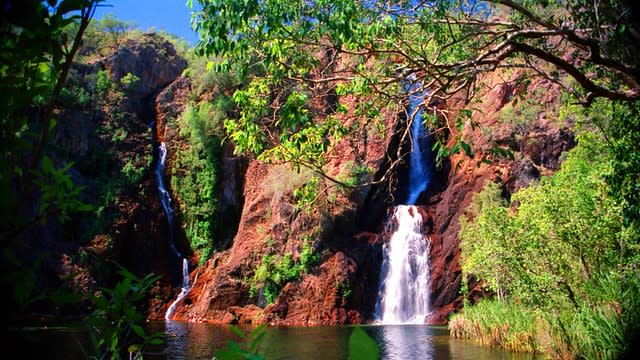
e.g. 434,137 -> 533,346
160,65 -> 575,325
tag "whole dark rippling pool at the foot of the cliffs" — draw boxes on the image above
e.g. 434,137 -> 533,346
14,321 -> 536,360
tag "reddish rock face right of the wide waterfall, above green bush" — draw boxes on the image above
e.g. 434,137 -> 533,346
422,74 -> 575,324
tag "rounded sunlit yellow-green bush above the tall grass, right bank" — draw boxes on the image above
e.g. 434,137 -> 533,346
460,135 -> 625,307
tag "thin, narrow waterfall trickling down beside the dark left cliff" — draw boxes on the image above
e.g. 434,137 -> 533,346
156,142 -> 190,320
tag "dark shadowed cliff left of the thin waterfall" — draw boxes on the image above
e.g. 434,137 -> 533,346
47,34 -> 188,316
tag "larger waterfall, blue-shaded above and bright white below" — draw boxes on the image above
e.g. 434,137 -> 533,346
374,80 -> 431,324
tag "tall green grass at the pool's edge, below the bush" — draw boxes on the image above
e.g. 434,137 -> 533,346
449,275 -> 640,360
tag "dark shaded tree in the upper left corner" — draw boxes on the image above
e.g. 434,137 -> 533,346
0,0 -> 102,239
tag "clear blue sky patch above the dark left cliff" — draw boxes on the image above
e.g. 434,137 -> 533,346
94,0 -> 197,45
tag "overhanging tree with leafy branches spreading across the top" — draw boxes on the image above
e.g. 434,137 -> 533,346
194,0 -> 640,186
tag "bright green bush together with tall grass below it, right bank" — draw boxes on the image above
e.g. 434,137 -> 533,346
458,132 -> 640,359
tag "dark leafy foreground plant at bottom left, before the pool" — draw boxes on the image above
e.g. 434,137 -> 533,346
84,267 -> 162,359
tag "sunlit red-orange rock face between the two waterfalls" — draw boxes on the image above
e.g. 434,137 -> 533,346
168,86 -> 395,325
